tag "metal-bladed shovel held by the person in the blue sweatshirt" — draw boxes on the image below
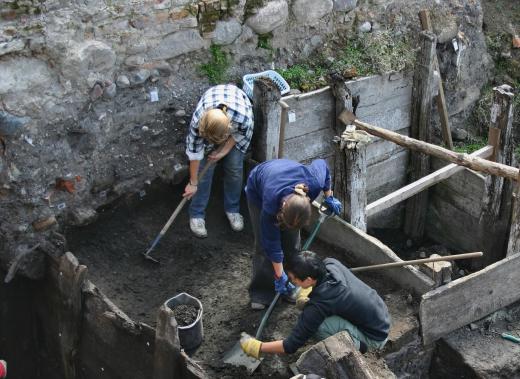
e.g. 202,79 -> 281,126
223,206 -> 332,375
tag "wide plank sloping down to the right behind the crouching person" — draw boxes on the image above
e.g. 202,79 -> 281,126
313,202 -> 434,294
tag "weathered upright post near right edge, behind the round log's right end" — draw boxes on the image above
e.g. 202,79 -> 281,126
480,85 -> 514,265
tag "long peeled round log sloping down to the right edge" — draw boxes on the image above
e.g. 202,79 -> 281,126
340,112 -> 519,180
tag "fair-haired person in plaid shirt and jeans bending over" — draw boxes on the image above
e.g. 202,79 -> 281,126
183,84 -> 253,238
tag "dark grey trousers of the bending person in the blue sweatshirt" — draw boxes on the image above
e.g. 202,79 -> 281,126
247,202 -> 300,305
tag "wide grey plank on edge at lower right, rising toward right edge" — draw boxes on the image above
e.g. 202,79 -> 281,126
419,254 -> 520,345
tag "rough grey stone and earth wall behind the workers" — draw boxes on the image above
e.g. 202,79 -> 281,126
0,0 -> 489,278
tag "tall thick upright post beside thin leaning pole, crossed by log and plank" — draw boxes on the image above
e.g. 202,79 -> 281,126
404,32 -> 436,240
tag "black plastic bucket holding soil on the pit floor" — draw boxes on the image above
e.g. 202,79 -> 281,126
164,292 -> 204,351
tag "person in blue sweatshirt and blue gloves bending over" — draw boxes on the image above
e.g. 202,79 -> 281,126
245,159 -> 341,309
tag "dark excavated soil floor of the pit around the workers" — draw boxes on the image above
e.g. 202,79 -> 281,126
67,172 -> 397,378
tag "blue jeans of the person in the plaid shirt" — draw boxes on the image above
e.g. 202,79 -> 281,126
190,147 -> 244,218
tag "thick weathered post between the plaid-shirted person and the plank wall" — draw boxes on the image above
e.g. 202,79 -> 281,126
253,78 -> 282,162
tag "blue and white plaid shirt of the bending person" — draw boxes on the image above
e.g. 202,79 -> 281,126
186,84 -> 253,161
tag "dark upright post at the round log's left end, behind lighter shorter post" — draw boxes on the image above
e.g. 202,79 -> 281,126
331,78 -> 353,220
